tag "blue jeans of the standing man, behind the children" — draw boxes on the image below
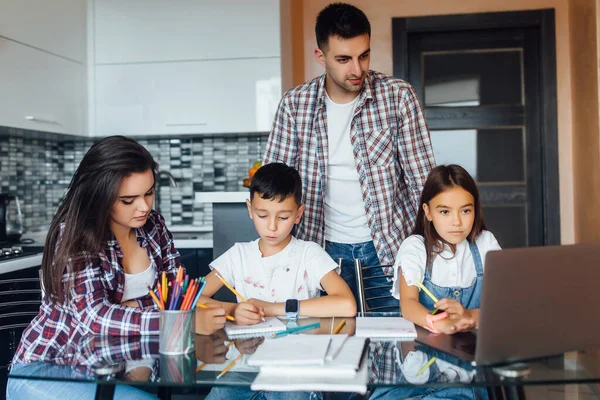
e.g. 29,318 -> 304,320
325,242 -> 400,312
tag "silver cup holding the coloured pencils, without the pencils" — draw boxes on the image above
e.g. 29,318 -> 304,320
158,310 -> 196,354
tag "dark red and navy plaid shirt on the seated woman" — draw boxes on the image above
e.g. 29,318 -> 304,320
13,211 -> 181,365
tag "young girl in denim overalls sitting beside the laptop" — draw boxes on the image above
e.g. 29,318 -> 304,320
372,165 -> 500,399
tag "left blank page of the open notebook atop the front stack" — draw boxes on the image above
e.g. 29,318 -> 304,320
248,334 -> 331,367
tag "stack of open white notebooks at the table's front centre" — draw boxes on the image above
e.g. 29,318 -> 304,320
248,334 -> 368,394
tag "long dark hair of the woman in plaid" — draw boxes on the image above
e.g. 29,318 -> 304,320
42,136 -> 158,301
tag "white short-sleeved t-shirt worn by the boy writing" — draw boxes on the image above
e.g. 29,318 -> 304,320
210,236 -> 340,303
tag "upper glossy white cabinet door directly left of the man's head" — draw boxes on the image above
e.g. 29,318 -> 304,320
94,0 -> 281,65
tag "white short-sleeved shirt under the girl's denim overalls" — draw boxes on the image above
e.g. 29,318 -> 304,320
391,231 -> 500,299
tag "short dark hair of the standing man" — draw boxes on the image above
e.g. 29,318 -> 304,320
315,3 -> 371,51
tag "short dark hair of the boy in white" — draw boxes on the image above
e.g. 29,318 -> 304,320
250,163 -> 302,206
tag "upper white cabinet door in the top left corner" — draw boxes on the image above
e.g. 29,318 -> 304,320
0,0 -> 86,63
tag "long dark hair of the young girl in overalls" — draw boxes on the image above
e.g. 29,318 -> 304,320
413,164 -> 486,268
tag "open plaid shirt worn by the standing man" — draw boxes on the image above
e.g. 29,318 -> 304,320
264,71 -> 435,272
